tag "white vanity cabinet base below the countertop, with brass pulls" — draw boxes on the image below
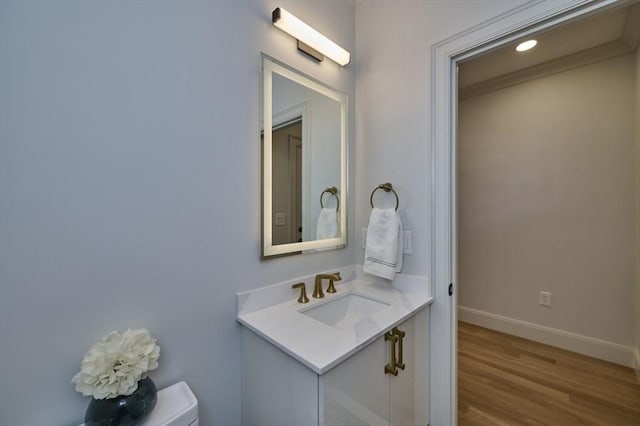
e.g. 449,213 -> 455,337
242,308 -> 429,426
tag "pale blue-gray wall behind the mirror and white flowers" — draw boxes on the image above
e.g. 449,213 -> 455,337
0,0 -> 355,426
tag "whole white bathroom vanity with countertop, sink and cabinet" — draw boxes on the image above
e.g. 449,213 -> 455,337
238,268 -> 432,426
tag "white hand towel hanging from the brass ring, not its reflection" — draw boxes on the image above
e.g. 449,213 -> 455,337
363,207 -> 403,280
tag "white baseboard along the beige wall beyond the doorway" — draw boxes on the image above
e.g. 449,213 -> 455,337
458,306 -> 640,368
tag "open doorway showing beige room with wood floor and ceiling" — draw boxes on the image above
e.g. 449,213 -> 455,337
457,6 -> 640,426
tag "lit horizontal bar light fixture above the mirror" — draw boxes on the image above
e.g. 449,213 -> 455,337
271,7 -> 351,66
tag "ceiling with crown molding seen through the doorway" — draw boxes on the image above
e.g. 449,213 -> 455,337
458,1 -> 640,89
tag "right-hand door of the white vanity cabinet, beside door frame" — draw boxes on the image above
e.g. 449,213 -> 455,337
390,309 -> 429,426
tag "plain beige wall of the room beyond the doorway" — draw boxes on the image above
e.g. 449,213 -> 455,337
458,55 -> 636,347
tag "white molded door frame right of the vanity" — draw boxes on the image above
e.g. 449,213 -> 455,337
429,0 -> 633,426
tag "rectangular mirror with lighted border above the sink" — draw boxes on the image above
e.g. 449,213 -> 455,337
261,54 -> 347,258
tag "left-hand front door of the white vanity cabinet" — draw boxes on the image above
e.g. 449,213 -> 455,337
319,338 -> 391,426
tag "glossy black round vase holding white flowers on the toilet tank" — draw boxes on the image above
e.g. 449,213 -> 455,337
84,377 -> 158,426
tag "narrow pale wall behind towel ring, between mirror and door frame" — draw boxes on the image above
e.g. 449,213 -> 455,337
355,0 -> 526,276
